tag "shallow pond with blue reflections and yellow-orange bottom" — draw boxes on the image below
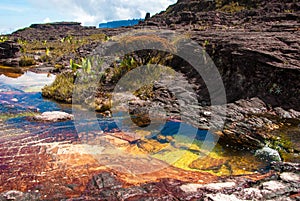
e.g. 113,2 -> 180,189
0,67 -> 268,181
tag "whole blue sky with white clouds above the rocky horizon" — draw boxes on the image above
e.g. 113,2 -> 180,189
0,0 -> 176,34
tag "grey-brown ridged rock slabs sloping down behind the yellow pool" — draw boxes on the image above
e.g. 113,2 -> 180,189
148,83 -> 297,150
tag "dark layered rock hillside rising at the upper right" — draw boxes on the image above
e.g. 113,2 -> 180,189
138,0 -> 300,110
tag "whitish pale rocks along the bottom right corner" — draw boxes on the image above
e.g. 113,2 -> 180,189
180,162 -> 300,201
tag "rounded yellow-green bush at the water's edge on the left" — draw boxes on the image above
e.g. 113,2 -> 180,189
42,72 -> 75,103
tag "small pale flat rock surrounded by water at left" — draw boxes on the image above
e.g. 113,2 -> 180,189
33,111 -> 73,122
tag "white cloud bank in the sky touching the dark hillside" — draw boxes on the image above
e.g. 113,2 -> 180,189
30,0 -> 176,25
